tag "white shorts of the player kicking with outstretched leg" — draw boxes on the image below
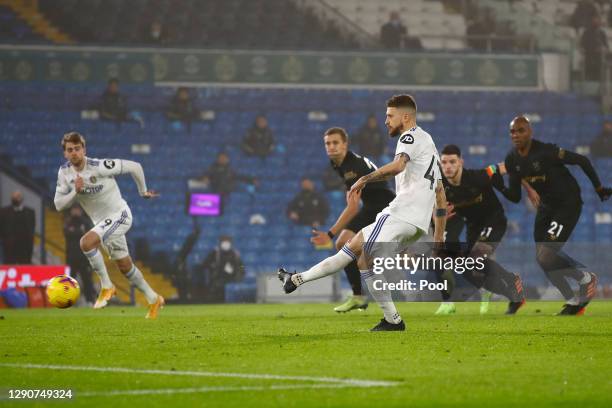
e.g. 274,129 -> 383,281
361,213 -> 423,256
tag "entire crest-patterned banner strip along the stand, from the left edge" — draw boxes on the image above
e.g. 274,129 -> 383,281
0,46 -> 541,89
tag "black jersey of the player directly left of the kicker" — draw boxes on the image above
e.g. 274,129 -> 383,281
331,150 -> 395,208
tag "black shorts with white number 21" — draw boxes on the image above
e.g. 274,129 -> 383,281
533,202 -> 582,243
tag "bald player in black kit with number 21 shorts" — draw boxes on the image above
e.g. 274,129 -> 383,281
500,116 -> 612,315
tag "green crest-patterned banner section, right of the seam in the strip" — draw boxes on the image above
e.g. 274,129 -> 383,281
153,51 -> 539,89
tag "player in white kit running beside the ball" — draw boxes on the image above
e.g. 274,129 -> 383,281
54,132 -> 164,319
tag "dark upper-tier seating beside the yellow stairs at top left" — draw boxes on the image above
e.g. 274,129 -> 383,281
38,0 -> 356,49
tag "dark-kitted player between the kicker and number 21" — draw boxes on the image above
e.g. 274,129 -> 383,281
436,145 -> 525,314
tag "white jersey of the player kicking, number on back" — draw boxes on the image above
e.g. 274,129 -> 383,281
382,126 -> 442,232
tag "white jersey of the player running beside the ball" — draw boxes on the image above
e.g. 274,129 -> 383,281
56,157 -> 128,224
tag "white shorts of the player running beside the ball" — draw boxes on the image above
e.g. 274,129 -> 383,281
91,207 -> 132,260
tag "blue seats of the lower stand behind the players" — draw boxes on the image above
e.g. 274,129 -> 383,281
0,82 -> 612,288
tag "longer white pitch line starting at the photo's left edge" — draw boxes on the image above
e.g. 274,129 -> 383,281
0,363 -> 399,387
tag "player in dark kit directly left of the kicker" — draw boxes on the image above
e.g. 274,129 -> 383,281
311,127 -> 395,313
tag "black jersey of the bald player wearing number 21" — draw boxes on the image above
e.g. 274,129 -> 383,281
505,139 -> 582,206
